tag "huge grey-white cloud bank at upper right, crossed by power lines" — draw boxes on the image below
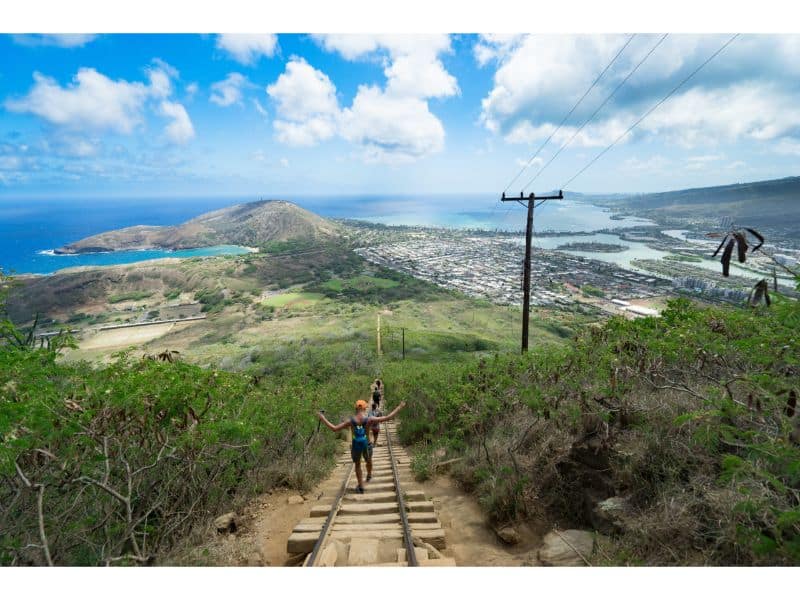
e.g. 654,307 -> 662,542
482,35 -> 800,155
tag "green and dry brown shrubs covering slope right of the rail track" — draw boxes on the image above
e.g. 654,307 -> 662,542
390,288 -> 800,565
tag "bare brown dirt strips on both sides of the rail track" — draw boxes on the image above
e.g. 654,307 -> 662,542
179,452 -> 543,566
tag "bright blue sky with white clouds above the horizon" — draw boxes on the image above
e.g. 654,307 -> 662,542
0,34 -> 800,198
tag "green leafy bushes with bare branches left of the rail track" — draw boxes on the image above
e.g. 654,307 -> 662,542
0,290 -> 367,565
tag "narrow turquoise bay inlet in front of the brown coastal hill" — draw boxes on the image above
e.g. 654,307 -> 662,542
23,246 -> 250,275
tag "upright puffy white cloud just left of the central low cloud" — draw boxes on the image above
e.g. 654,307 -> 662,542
267,57 -> 339,146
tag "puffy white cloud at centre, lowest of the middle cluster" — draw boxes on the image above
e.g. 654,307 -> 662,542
341,86 -> 444,163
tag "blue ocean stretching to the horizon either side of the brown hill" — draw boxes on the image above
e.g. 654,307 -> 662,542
0,194 -> 649,274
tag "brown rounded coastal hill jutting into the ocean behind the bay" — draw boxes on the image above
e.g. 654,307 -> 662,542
55,200 -> 341,254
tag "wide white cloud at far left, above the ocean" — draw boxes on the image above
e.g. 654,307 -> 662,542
5,68 -> 151,133
